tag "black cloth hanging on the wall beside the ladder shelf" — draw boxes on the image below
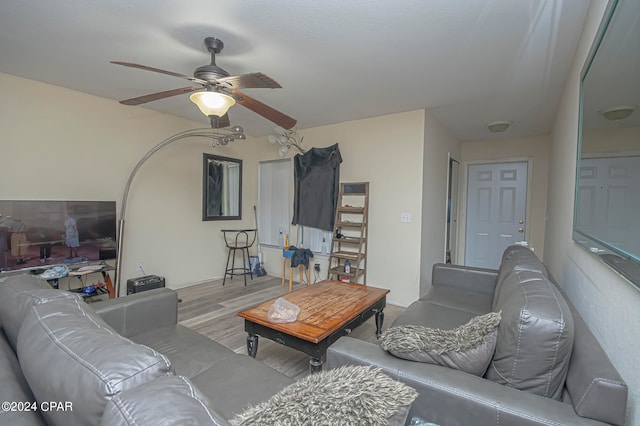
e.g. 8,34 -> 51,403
291,144 -> 342,232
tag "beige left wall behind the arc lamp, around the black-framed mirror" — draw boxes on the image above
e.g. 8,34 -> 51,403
0,74 -> 271,288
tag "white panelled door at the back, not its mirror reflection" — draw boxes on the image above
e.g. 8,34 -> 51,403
465,161 -> 528,269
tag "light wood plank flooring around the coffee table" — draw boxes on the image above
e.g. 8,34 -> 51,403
178,275 -> 404,379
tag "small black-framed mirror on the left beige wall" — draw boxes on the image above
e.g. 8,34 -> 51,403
202,154 -> 242,220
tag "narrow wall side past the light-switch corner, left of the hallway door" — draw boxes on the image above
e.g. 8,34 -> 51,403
420,111 -> 461,294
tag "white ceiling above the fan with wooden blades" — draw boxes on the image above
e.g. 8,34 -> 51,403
0,0 -> 590,140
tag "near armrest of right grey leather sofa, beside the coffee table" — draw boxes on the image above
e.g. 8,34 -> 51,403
327,337 -> 605,426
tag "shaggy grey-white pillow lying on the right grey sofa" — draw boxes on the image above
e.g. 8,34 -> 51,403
380,312 -> 501,376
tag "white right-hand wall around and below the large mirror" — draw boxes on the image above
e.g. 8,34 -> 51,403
544,0 -> 640,425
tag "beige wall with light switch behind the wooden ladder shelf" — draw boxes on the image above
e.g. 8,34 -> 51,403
264,110 -> 428,306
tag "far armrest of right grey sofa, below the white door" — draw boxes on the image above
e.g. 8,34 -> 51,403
431,263 -> 498,295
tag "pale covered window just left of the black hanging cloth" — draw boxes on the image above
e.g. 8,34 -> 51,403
258,159 -> 293,246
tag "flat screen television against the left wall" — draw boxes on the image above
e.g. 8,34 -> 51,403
0,200 -> 117,272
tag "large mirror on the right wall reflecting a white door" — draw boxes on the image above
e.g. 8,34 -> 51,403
573,0 -> 640,289
